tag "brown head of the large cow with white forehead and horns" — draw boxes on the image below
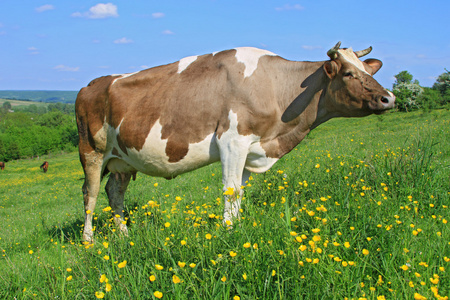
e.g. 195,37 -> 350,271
323,42 -> 395,117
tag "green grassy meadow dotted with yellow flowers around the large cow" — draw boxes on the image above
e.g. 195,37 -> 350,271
0,110 -> 450,300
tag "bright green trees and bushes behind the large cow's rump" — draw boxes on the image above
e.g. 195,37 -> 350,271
0,102 -> 78,161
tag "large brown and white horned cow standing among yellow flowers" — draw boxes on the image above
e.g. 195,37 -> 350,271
75,42 -> 395,242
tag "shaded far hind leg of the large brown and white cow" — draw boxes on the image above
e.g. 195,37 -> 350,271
105,173 -> 131,236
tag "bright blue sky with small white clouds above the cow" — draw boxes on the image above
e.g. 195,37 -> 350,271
0,0 -> 450,90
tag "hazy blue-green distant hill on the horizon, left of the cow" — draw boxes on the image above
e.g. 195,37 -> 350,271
0,91 -> 78,103
